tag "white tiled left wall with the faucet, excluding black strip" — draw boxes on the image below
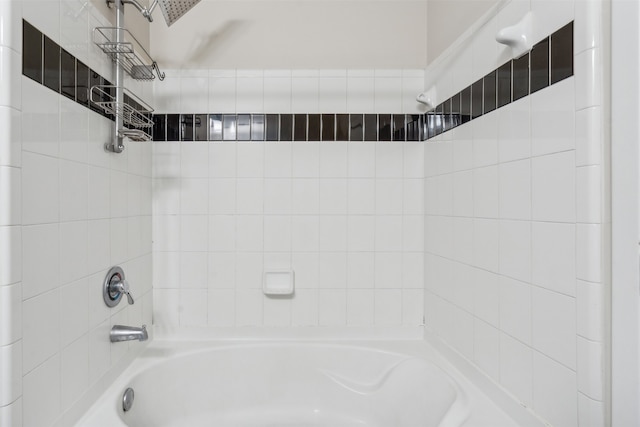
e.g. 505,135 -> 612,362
0,5 -> 151,426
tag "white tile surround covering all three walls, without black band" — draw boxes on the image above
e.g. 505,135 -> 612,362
0,0 -> 610,426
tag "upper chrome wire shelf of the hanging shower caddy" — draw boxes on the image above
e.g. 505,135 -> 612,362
93,27 -> 165,80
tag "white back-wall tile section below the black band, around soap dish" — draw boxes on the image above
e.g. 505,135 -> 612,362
153,142 -> 423,328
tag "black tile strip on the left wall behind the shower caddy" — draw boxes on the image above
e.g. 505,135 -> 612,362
22,20 -> 149,120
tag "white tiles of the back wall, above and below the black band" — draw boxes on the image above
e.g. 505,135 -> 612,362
153,70 -> 424,327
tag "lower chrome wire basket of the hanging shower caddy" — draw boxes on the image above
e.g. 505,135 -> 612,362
91,86 -> 153,141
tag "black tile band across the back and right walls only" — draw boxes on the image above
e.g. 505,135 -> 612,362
153,22 -> 573,141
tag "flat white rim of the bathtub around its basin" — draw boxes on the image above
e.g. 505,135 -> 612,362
72,327 -> 548,427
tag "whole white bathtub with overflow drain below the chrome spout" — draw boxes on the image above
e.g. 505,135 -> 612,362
77,341 -> 516,427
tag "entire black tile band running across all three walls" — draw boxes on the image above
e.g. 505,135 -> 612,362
22,20 -> 574,141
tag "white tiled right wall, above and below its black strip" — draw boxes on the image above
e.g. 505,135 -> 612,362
424,0 -> 608,426
